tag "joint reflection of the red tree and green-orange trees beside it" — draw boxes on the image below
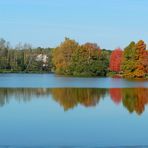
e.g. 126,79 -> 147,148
109,88 -> 148,115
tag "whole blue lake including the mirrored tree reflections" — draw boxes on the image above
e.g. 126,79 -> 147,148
0,74 -> 148,148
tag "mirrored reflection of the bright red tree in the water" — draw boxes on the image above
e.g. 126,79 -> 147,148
109,88 -> 122,104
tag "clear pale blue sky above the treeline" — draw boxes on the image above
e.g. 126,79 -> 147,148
0,0 -> 148,49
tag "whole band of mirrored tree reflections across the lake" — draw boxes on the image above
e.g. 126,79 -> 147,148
0,88 -> 148,115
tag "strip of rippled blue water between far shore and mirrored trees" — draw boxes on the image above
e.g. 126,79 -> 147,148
0,74 -> 148,88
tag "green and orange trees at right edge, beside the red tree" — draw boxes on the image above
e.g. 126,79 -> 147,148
122,40 -> 148,78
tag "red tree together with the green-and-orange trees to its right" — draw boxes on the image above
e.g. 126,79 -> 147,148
109,40 -> 148,78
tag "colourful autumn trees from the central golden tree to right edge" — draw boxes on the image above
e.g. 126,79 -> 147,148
53,38 -> 148,78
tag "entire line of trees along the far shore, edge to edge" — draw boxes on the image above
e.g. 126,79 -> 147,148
0,38 -> 148,78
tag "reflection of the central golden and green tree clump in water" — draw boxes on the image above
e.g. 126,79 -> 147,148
51,88 -> 107,110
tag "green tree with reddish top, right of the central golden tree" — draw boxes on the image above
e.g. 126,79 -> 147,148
70,43 -> 102,76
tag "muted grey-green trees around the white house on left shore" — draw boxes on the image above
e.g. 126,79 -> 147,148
0,39 -> 52,73
